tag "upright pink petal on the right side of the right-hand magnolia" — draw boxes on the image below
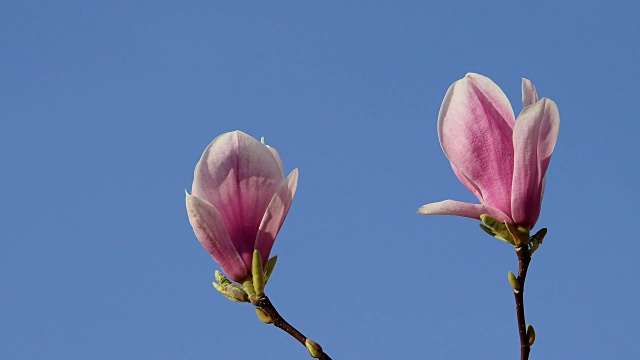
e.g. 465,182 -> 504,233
511,98 -> 560,227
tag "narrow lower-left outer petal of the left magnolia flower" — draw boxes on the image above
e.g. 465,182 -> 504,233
186,194 -> 247,281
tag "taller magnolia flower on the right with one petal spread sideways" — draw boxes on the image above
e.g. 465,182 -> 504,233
418,73 -> 560,229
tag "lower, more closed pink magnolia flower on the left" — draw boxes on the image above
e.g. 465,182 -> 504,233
186,131 -> 298,282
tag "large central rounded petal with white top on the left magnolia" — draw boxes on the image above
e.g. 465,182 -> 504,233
193,131 -> 284,264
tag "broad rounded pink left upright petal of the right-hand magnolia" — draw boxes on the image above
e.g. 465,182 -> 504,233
438,74 -> 514,216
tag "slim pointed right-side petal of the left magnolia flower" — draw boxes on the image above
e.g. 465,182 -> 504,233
255,169 -> 298,265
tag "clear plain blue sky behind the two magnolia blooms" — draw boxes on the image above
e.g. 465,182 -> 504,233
0,0 -> 640,360
